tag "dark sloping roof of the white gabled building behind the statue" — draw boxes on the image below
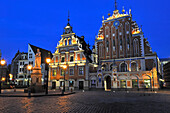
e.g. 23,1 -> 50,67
29,44 -> 52,63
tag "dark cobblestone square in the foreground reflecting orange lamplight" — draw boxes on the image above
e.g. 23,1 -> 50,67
0,91 -> 170,113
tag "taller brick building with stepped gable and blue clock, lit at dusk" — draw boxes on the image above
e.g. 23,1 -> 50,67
89,3 -> 160,90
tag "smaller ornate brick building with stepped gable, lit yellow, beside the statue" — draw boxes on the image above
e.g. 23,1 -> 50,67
49,22 -> 92,90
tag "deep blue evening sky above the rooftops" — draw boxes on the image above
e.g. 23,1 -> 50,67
0,0 -> 170,64
